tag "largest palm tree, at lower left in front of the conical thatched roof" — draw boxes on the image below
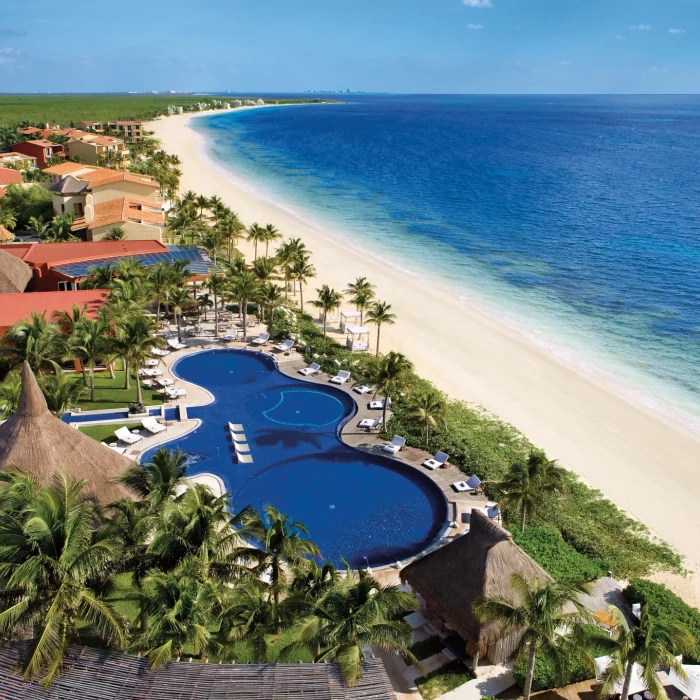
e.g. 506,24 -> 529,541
0,475 -> 127,683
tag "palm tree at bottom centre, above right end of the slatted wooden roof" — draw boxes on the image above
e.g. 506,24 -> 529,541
284,572 -> 418,686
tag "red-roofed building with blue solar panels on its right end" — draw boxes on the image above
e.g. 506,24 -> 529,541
0,240 -> 219,292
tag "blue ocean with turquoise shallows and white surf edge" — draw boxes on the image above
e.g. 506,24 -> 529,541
193,95 -> 700,429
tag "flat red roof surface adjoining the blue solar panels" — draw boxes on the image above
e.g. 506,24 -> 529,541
0,240 -> 168,267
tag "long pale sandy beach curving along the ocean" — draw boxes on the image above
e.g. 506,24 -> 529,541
147,107 -> 700,566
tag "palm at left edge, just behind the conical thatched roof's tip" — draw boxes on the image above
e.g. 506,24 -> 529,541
2,311 -> 65,373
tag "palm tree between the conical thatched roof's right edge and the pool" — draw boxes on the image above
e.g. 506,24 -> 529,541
119,447 -> 187,512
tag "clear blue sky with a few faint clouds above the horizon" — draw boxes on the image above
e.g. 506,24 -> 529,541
0,0 -> 700,94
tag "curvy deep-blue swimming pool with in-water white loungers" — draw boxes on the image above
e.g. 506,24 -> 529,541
141,350 -> 447,566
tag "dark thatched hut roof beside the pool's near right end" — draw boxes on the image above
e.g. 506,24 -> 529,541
401,510 -> 552,664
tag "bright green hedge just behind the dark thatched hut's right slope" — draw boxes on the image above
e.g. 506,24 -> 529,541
513,527 -> 605,583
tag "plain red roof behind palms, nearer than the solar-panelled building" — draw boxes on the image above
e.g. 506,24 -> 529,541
0,289 -> 108,338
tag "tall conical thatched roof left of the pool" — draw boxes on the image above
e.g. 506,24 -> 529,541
0,362 -> 133,503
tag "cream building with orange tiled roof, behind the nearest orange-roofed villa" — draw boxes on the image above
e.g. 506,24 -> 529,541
44,163 -> 160,216
